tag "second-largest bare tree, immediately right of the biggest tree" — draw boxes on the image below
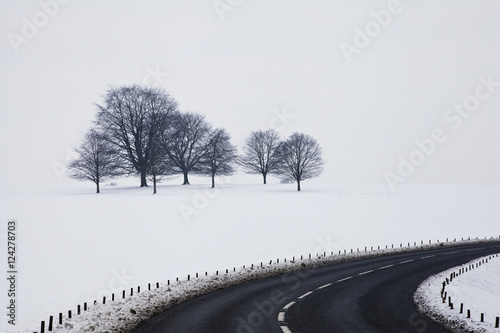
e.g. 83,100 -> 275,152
163,113 -> 211,185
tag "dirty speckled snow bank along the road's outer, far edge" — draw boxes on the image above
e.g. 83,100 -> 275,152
48,239 -> 500,333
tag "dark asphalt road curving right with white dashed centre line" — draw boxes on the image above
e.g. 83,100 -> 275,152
135,243 -> 500,333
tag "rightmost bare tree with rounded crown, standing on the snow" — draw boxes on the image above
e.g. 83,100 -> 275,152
279,133 -> 324,191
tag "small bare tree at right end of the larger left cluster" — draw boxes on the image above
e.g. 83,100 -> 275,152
202,128 -> 236,188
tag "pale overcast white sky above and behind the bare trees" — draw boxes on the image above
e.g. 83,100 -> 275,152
0,0 -> 500,188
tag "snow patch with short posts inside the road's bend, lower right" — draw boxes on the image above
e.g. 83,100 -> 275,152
414,254 -> 500,332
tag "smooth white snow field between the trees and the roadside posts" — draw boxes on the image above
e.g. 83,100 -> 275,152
0,178 -> 500,332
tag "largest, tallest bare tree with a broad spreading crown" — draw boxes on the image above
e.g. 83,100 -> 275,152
97,85 -> 177,187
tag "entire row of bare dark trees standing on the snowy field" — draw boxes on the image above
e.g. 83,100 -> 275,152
68,85 -> 323,193
